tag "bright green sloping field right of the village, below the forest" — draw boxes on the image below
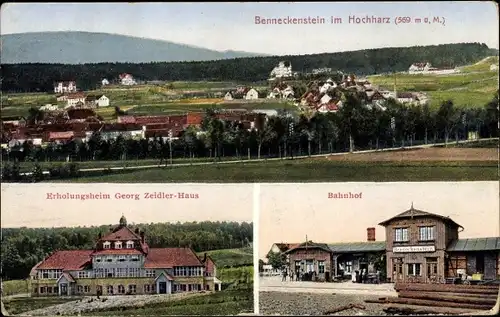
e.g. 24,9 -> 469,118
368,56 -> 498,109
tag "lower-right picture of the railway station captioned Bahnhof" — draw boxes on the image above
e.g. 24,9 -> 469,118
258,182 -> 500,316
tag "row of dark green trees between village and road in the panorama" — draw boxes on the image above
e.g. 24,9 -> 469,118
2,91 -> 499,181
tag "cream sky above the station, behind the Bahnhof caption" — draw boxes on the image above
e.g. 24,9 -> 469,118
260,182 -> 500,259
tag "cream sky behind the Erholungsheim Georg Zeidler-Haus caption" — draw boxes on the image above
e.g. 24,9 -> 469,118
1,183 -> 253,228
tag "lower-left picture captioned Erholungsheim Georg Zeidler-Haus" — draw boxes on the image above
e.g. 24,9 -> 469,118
1,184 -> 254,316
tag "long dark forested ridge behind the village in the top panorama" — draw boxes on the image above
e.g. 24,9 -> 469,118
2,43 -> 498,92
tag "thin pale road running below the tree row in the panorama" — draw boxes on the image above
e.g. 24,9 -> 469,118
21,138 -> 498,176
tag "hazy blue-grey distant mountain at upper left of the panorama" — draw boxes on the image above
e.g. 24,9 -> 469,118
1,31 -> 264,64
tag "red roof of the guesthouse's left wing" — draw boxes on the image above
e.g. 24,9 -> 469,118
37,250 -> 92,271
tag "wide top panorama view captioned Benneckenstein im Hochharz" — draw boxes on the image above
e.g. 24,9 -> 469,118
0,1 -> 499,183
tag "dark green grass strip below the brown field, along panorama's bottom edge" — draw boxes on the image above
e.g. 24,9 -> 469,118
46,159 -> 498,183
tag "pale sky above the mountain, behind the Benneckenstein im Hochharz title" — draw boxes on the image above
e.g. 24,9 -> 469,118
0,1 -> 499,55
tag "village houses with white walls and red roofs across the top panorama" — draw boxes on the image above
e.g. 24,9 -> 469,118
2,62 -> 446,150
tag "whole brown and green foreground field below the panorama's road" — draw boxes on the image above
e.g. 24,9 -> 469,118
49,148 -> 498,183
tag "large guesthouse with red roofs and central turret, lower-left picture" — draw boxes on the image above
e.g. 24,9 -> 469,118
29,216 -> 221,296
